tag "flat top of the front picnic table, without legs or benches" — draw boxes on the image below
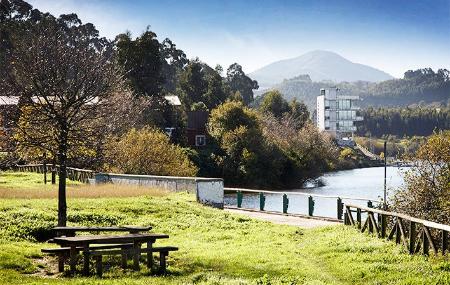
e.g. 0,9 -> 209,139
54,233 -> 169,245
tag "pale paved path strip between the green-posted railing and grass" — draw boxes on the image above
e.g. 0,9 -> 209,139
225,205 -> 340,228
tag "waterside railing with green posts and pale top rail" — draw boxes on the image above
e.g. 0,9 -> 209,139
224,188 -> 383,220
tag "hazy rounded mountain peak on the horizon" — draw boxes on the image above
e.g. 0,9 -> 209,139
249,50 -> 393,88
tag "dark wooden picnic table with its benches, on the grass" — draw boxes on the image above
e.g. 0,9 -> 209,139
53,233 -> 171,275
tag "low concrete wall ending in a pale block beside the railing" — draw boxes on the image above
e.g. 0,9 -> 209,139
93,173 -> 224,208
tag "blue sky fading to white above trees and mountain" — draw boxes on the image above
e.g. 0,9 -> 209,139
28,0 -> 450,77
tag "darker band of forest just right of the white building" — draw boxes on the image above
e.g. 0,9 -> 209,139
357,107 -> 450,137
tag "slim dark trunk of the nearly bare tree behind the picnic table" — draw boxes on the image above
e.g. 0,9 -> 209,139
58,130 -> 67,227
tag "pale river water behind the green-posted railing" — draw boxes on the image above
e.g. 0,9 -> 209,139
225,167 -> 407,218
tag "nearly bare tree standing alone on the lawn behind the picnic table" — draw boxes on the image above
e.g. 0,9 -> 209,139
0,14 -> 122,226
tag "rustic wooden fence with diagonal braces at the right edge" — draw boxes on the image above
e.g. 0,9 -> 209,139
344,204 -> 450,255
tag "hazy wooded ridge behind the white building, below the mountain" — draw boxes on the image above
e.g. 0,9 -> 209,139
260,68 -> 450,112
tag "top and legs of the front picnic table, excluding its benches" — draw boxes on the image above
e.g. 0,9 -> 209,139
53,233 -> 169,275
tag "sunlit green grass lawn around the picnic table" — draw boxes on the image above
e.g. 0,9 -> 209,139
0,170 -> 450,284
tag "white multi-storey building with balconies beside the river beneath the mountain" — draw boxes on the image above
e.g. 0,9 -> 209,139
317,88 -> 363,138
